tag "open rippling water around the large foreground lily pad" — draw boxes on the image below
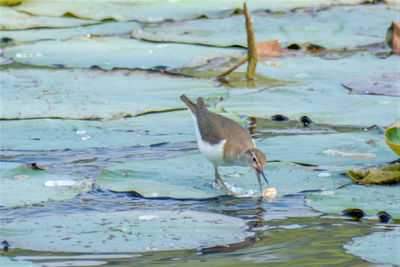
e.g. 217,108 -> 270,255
0,142 -> 389,266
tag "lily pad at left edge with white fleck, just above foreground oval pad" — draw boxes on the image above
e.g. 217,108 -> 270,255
0,162 -> 92,207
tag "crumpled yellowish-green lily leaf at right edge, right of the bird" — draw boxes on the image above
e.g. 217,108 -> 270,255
349,164 -> 400,184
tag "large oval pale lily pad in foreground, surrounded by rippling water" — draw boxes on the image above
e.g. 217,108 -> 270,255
2,209 -> 251,253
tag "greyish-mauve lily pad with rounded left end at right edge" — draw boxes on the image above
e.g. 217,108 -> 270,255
342,72 -> 400,96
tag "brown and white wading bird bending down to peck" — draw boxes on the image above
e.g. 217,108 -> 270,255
180,94 -> 269,195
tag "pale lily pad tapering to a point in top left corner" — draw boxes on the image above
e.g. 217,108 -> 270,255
0,6 -> 97,30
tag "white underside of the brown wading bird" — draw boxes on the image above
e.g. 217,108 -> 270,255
190,113 -> 226,166
